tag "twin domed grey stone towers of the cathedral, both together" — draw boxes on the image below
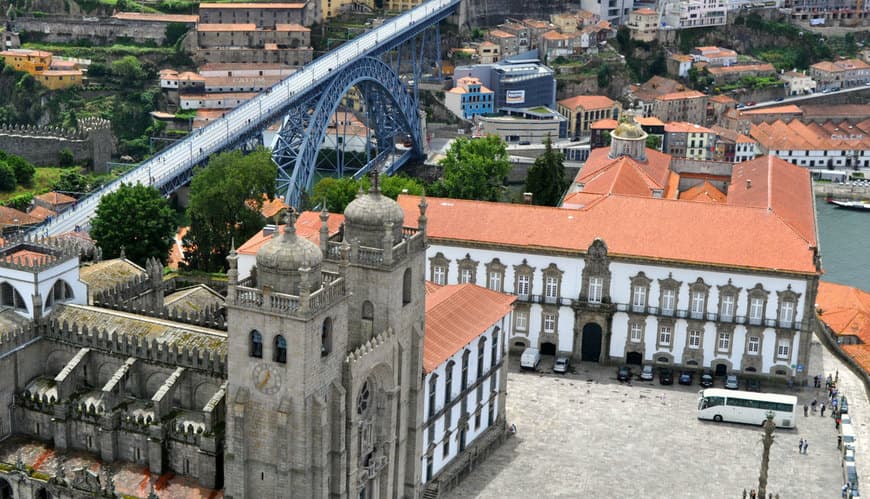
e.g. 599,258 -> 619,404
225,173 -> 426,499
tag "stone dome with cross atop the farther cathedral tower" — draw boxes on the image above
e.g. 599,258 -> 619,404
344,171 -> 405,249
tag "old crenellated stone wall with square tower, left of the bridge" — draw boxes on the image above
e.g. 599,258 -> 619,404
0,118 -> 115,173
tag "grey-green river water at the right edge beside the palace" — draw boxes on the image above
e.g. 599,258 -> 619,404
816,198 -> 870,291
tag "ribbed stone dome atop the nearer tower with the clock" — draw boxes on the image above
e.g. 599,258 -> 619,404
257,213 -> 323,295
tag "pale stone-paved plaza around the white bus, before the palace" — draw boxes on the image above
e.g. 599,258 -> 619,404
448,338 -> 856,499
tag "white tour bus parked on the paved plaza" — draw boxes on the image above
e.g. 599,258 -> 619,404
698,388 -> 797,428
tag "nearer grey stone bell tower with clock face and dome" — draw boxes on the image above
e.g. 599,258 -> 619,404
224,213 -> 347,499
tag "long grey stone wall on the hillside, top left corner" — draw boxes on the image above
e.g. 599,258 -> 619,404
15,16 -> 193,45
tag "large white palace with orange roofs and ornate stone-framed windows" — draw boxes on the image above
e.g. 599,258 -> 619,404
399,118 -> 821,381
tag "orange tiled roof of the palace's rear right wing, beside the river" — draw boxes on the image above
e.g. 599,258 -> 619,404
728,156 -> 816,246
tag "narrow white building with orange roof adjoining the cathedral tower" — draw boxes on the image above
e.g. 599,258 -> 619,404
420,284 -> 516,484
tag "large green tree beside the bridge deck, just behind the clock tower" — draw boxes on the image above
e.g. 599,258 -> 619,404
184,148 -> 277,271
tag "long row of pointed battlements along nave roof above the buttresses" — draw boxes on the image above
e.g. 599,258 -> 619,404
45,320 -> 227,377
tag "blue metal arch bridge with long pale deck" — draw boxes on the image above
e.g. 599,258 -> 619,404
32,0 -> 460,235
